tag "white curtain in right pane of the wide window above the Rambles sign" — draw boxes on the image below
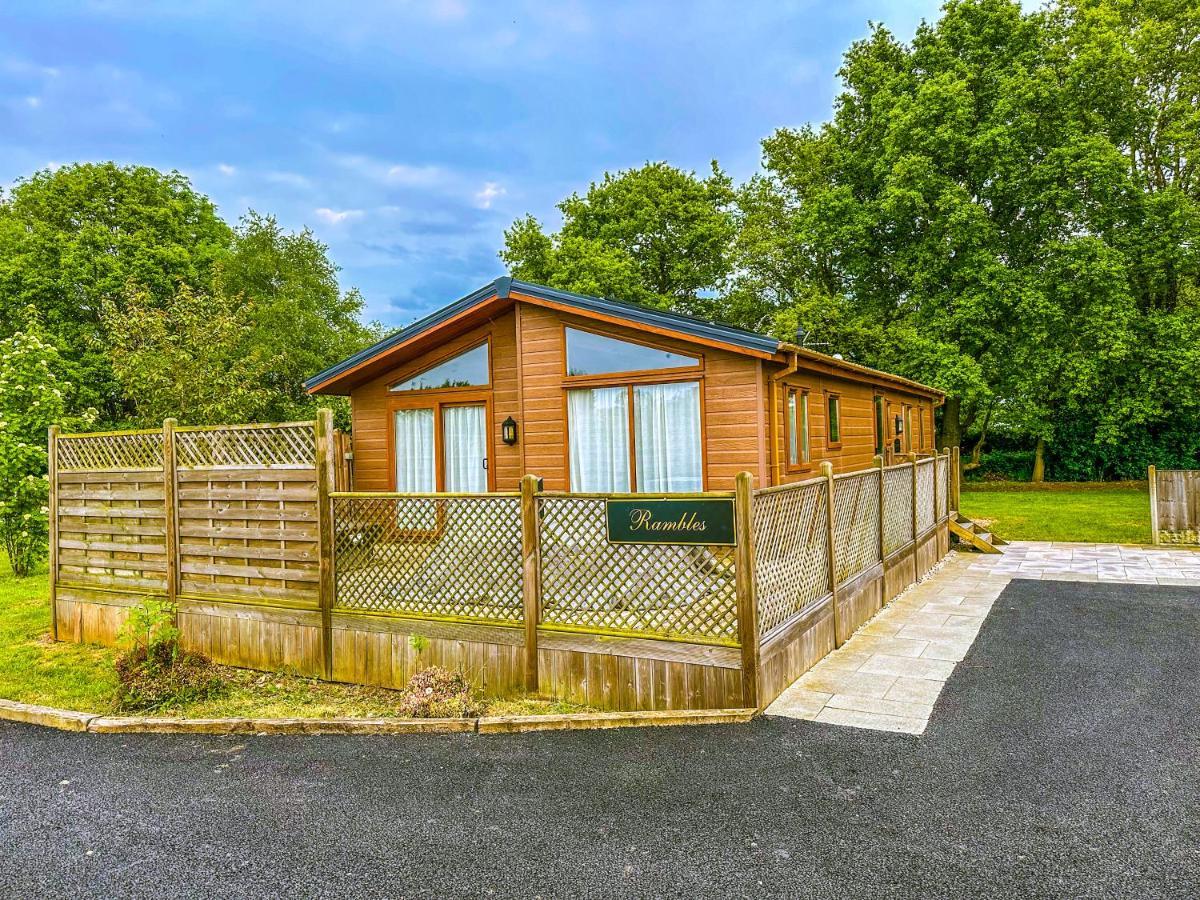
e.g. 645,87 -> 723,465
634,382 -> 703,493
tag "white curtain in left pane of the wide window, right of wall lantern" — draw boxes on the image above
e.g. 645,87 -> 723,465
566,388 -> 630,493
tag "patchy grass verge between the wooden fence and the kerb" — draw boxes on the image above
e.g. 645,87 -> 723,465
0,561 -> 587,719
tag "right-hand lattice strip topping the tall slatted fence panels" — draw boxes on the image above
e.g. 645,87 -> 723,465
175,422 -> 317,468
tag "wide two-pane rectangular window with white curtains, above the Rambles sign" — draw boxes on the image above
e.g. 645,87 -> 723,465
566,382 -> 703,493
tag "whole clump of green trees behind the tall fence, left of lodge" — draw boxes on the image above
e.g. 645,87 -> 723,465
0,163 -> 376,426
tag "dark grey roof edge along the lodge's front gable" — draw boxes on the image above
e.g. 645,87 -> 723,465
304,276 -> 779,390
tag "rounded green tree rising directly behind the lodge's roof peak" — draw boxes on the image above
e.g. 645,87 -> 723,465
499,162 -> 734,311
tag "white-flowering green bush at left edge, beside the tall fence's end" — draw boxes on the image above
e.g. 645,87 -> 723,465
0,324 -> 91,576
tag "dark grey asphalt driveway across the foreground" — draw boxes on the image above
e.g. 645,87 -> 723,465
0,581 -> 1200,898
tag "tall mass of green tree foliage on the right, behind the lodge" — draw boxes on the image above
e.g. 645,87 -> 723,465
727,0 -> 1200,480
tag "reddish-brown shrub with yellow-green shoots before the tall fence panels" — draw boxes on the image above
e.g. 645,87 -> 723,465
115,600 -> 224,712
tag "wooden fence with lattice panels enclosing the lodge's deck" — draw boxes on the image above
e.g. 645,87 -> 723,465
50,412 -> 954,709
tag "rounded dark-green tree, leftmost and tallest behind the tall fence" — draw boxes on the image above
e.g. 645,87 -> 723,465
0,162 -> 233,422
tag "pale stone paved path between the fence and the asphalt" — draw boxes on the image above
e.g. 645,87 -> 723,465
767,541 -> 1200,734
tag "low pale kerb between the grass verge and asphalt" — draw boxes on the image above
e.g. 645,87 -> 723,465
0,700 -> 756,734
